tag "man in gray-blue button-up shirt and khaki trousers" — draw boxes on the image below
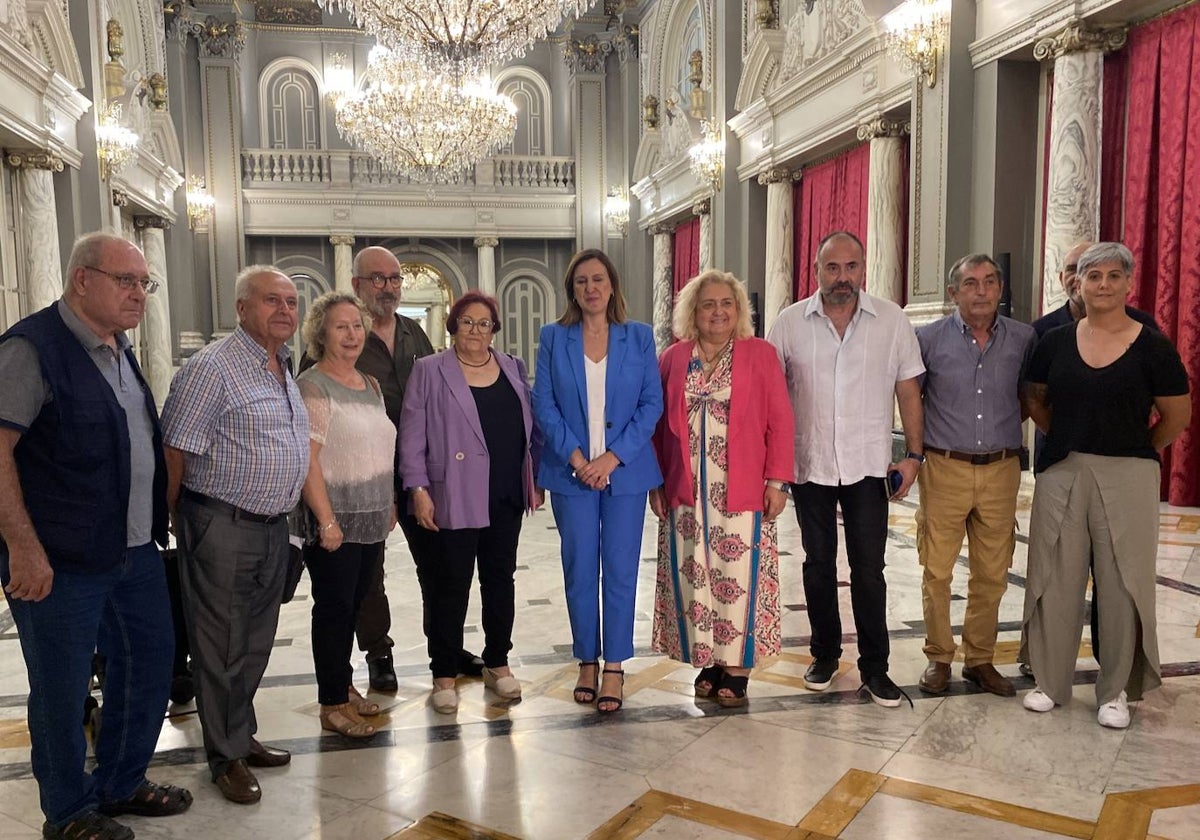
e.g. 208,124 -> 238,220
917,253 -> 1037,697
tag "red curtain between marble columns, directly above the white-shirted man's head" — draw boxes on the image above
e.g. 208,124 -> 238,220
792,143 -> 871,300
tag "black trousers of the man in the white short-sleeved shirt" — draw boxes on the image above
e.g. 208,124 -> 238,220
792,478 -> 890,678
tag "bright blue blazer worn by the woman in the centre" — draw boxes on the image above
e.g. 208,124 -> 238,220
533,322 -> 662,494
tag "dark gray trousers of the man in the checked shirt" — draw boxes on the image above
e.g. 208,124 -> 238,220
176,498 -> 288,780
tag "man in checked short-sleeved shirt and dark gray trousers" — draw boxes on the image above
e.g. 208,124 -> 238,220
162,265 -> 308,804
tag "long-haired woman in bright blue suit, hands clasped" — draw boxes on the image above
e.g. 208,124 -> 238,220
533,248 -> 662,713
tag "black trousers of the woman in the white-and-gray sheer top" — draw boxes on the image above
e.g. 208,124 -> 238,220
304,542 -> 384,706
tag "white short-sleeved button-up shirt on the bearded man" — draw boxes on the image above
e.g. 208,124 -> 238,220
767,293 -> 925,486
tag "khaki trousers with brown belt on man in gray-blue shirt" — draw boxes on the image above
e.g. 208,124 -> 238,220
917,454 -> 1021,666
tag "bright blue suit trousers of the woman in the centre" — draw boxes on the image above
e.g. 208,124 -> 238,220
550,490 -> 646,662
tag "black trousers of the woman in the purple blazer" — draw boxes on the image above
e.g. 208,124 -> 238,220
432,506 -> 522,678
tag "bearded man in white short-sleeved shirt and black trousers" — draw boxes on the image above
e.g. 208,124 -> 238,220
768,230 -> 925,707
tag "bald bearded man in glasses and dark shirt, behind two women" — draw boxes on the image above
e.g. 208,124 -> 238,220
338,246 -> 484,691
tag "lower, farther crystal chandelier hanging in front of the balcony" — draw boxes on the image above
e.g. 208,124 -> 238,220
335,47 -> 517,184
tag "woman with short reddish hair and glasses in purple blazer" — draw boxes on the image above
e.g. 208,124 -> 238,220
400,292 -> 542,714
